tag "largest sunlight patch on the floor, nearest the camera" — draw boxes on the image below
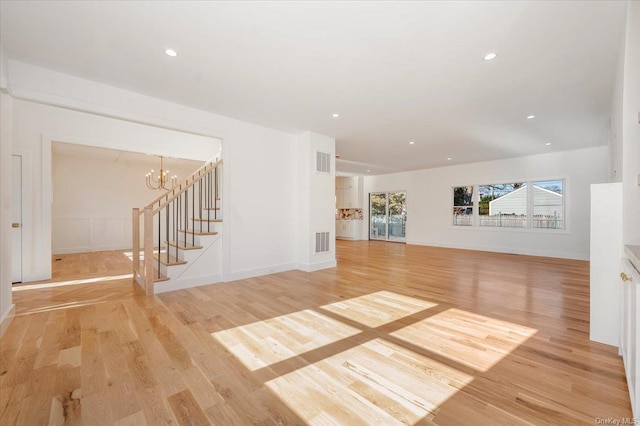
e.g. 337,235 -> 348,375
266,338 -> 473,425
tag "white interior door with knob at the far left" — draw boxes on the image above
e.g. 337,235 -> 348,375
11,155 -> 22,283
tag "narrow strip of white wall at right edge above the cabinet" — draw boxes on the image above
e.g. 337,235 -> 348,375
622,1 -> 640,244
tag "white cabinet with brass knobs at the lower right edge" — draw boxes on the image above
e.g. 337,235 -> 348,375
619,251 -> 640,418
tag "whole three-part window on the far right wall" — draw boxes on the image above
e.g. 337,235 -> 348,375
453,179 -> 566,229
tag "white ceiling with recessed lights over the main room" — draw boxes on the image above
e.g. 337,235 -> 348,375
0,1 -> 626,174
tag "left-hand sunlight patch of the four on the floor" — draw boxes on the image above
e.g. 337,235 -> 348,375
211,309 -> 360,371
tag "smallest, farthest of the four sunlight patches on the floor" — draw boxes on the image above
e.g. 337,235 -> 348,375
321,291 -> 437,328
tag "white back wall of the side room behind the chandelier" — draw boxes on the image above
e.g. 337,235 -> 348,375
51,150 -> 203,254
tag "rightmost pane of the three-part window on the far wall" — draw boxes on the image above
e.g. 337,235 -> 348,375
531,180 -> 564,229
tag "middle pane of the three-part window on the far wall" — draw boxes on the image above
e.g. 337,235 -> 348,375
478,182 -> 528,228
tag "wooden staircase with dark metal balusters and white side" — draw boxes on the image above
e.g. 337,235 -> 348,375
132,157 -> 222,296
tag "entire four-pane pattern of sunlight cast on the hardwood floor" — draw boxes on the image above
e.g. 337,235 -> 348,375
211,291 -> 537,425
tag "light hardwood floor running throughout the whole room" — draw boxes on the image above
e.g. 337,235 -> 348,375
0,241 -> 631,425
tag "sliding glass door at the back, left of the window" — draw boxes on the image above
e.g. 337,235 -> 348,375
369,191 -> 407,241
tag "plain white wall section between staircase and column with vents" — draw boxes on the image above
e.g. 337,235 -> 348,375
221,122 -> 296,281
